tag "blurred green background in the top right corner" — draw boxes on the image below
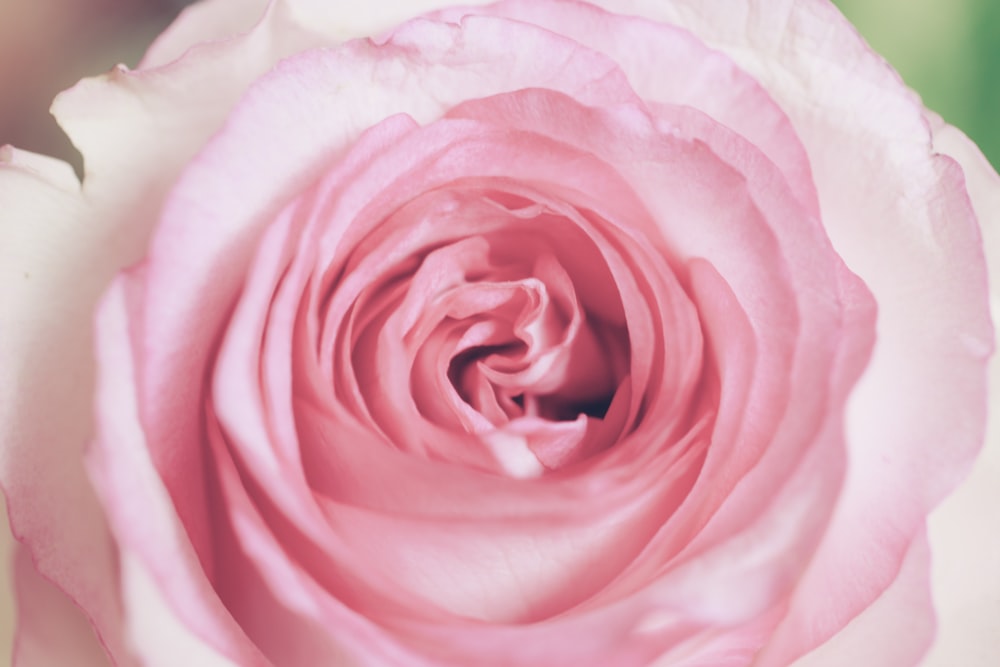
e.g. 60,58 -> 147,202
834,0 -> 1000,167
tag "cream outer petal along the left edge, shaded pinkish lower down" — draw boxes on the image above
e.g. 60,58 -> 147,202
0,147 -> 130,665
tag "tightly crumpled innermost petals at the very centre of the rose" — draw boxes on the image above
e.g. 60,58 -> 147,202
402,237 -> 627,475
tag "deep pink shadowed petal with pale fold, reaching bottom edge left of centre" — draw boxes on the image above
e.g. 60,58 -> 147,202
208,402 -> 425,667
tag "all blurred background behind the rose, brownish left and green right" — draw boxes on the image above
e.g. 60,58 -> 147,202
0,0 -> 1000,665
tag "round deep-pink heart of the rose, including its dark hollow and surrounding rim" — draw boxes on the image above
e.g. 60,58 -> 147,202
353,191 -> 630,477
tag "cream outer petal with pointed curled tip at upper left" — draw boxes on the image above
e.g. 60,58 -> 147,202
52,0 -> 496,232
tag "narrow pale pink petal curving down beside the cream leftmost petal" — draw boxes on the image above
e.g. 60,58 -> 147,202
87,277 -> 266,666
